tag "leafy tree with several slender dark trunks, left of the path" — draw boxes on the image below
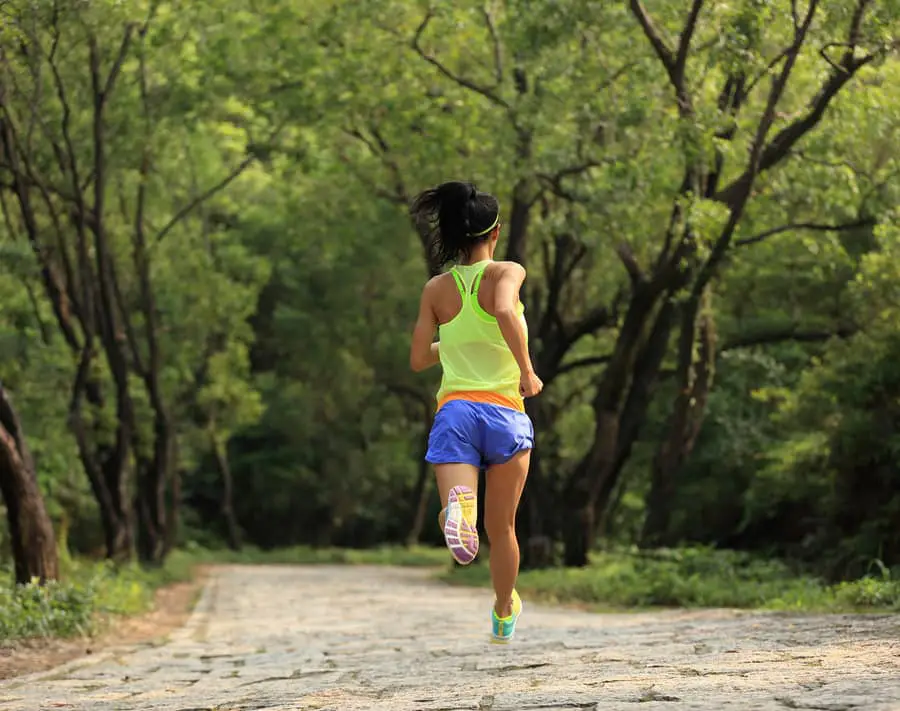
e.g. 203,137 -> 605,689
0,0 -> 272,562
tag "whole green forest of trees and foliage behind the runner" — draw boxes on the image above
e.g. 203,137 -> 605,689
0,0 -> 900,636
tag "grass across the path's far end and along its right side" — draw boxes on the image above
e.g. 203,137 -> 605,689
189,546 -> 900,612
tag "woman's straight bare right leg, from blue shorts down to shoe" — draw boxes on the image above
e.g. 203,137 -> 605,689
484,449 -> 531,617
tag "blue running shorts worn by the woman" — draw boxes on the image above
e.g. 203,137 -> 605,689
425,400 -> 534,468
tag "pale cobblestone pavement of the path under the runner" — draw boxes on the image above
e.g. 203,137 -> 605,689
0,566 -> 900,711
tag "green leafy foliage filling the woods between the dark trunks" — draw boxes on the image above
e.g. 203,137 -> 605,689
0,0 -> 900,584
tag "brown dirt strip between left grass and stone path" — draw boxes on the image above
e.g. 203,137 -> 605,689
0,566 -> 210,680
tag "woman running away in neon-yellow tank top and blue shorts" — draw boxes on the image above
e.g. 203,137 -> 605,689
409,182 -> 543,642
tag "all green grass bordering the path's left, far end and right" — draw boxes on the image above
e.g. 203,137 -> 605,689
0,546 -> 900,644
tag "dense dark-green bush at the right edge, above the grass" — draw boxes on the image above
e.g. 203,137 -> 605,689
746,222 -> 900,576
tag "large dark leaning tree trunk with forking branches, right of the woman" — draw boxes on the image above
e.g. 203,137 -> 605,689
566,0 -> 894,565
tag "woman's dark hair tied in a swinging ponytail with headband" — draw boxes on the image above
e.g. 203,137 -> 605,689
409,181 -> 500,267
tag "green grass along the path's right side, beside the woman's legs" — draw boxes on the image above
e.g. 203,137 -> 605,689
439,548 -> 900,612
